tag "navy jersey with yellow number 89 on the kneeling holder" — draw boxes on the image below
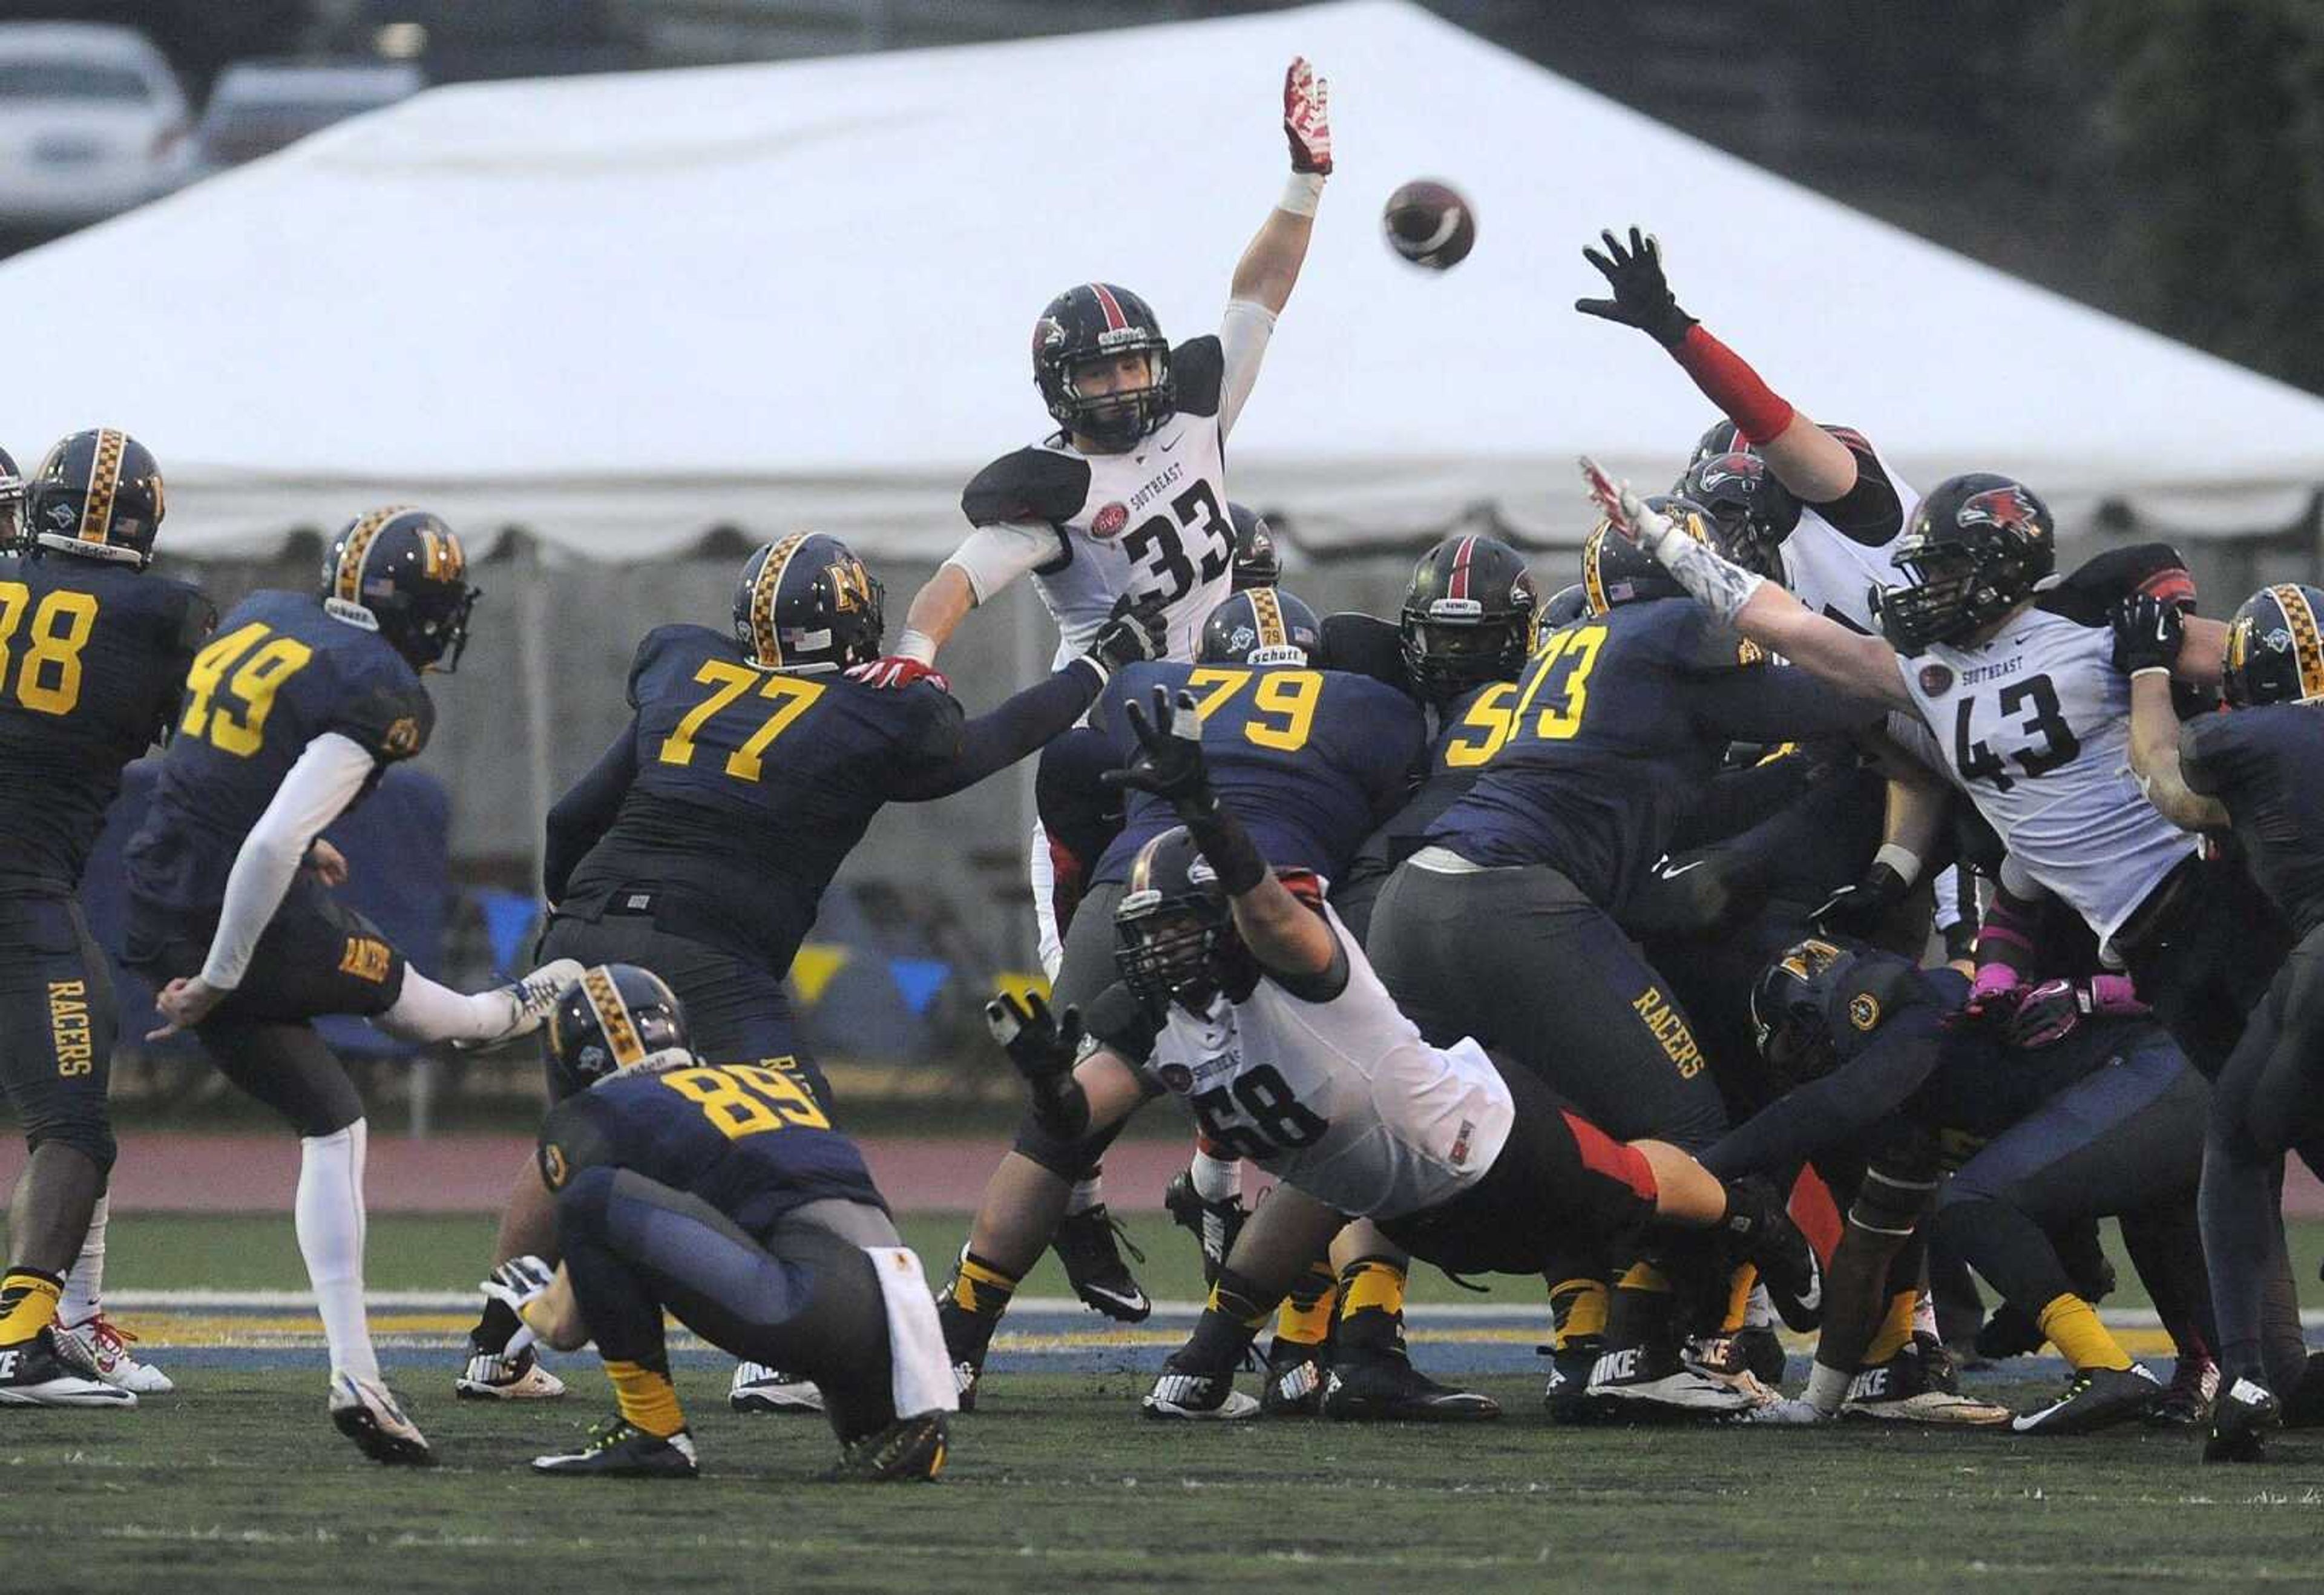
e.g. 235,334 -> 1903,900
539,1058 -> 885,1237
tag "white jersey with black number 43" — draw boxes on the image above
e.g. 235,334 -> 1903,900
1896,609 -> 2194,942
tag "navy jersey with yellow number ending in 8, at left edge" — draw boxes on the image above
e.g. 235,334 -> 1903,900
0,556 -> 216,886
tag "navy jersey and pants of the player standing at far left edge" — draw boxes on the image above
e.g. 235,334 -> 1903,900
0,556 -> 216,1165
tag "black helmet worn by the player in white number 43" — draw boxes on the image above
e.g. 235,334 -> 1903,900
1876,472 -> 2056,653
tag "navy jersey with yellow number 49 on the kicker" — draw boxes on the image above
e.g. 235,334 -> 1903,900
125,593 -> 435,914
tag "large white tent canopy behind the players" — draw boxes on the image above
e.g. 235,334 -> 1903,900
0,0 -> 2324,558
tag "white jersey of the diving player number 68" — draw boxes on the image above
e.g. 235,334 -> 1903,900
1146,909 -> 1515,1218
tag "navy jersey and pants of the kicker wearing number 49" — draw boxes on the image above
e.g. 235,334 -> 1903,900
123,593 -> 435,1023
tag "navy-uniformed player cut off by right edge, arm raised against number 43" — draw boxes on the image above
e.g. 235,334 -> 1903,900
2115,584 -> 2324,1462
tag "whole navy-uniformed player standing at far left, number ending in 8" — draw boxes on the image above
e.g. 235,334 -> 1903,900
0,430 -> 218,1407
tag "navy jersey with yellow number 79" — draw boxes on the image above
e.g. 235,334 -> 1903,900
1090,660 -> 1427,881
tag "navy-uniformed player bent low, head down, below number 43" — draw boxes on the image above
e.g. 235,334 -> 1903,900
1704,939 -> 2210,1435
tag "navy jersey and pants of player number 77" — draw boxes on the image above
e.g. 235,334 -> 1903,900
542,625 -> 1097,1074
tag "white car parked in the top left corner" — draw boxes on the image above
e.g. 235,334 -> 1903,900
0,23 -> 193,230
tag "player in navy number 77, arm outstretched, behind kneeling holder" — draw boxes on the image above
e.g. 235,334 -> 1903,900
456,533 -> 1160,1407
